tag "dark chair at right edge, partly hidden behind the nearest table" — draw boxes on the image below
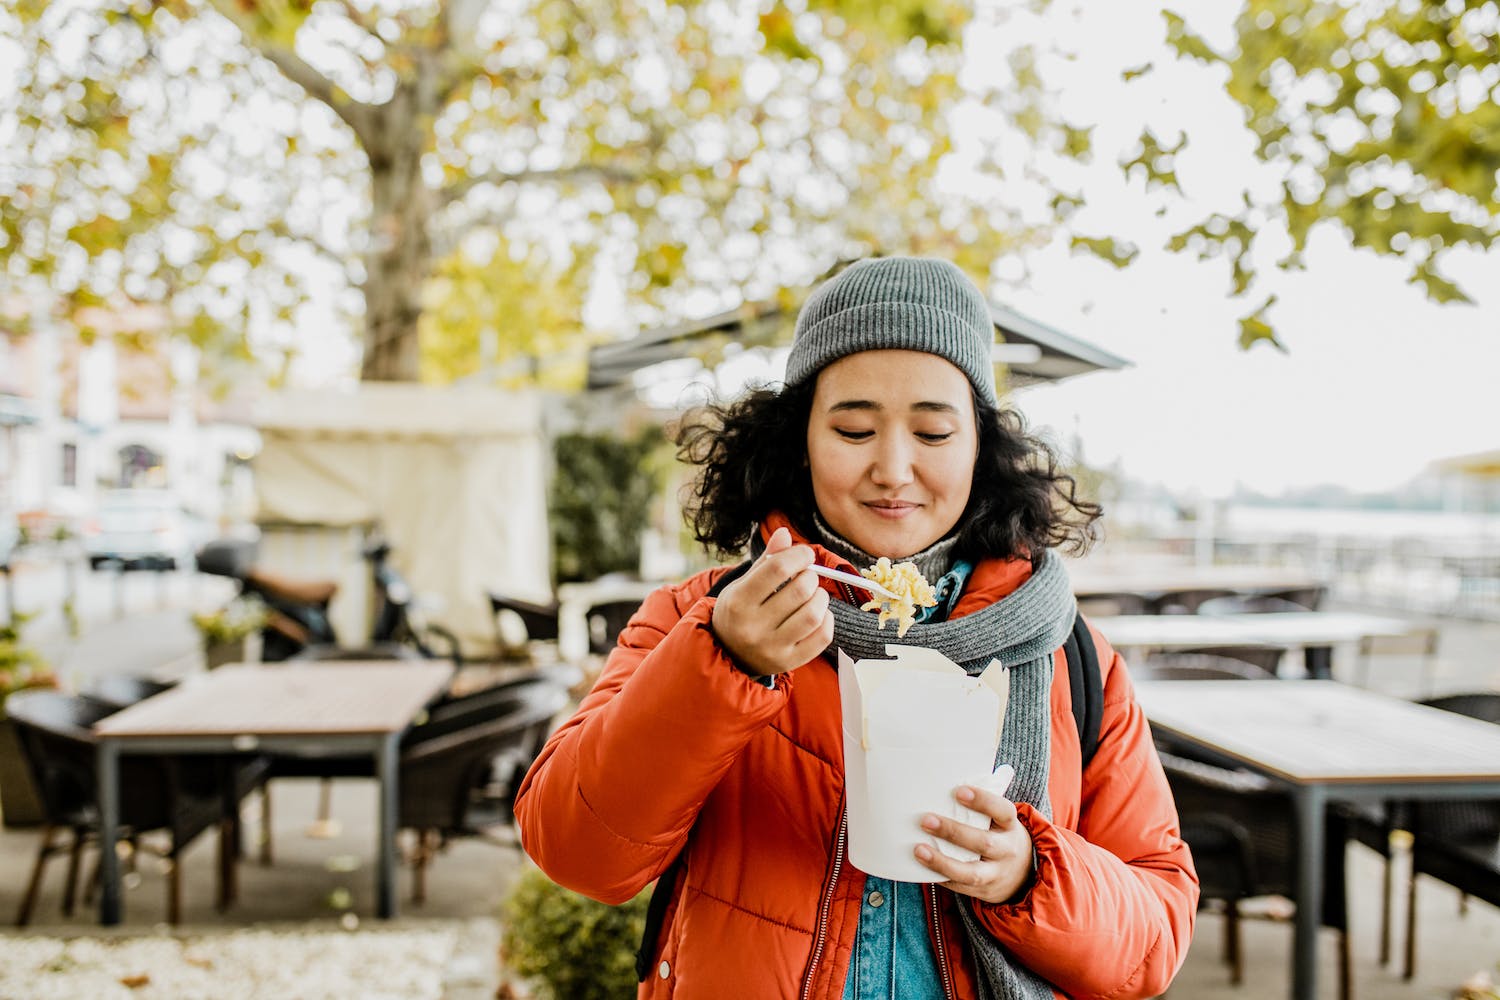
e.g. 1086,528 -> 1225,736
1352,691 -> 1500,979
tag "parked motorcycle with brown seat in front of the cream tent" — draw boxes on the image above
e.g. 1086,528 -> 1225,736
197,538 -> 462,666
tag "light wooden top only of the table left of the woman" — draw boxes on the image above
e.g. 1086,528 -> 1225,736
95,660 -> 453,739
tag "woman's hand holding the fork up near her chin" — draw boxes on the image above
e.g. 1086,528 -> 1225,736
711,528 -> 834,676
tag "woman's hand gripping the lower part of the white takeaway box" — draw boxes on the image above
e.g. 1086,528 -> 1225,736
917,786 -> 1034,903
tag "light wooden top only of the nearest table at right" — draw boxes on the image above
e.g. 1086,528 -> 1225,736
1136,681 -> 1500,784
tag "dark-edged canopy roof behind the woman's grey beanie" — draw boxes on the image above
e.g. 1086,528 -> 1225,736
588,301 -> 1130,390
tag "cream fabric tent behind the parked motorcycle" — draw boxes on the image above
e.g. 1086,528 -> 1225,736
254,382 -> 551,651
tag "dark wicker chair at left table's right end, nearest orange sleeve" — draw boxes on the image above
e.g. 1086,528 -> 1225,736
398,678 -> 567,904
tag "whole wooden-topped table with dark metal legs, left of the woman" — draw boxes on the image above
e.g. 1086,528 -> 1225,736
95,660 -> 453,925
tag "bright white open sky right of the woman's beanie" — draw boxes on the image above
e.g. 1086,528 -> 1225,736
966,0 -> 1500,495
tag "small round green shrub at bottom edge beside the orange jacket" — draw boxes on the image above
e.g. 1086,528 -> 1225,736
504,868 -> 651,1000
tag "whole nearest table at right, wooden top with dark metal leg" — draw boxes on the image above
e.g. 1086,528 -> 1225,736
1136,681 -> 1500,1000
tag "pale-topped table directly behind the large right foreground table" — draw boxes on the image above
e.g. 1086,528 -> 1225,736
1089,612 -> 1412,681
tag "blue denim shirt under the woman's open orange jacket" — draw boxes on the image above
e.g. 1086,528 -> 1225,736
843,559 -> 974,1000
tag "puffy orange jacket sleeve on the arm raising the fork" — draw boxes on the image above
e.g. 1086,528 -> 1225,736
516,574 -> 791,904
